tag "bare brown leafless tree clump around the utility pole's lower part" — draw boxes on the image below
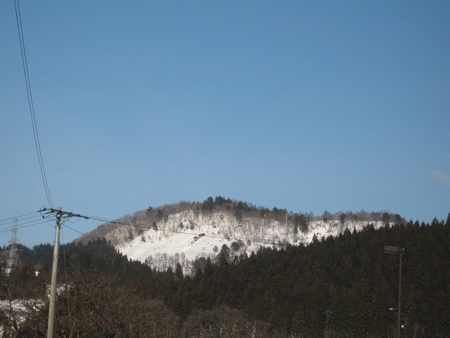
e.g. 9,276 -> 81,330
18,270 -> 178,337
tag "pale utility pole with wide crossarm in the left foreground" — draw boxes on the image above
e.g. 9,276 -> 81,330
44,207 -> 89,338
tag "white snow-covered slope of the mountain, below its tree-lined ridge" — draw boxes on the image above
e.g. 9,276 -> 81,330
97,208 -> 383,273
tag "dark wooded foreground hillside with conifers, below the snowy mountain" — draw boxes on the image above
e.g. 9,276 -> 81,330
0,214 -> 450,337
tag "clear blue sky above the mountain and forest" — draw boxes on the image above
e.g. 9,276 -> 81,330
0,0 -> 450,246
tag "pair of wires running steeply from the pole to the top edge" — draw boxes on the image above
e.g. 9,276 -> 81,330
14,0 -> 53,206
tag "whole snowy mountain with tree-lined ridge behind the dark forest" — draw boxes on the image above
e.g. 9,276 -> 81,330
78,196 -> 401,273
